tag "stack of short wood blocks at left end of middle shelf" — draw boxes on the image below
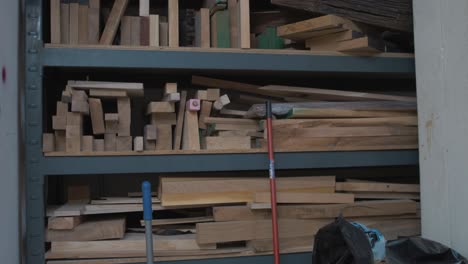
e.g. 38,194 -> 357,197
43,81 -> 144,153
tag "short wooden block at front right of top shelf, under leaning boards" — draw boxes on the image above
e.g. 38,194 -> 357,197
336,37 -> 385,54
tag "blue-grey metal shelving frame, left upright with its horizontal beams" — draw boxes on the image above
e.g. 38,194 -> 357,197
23,0 -> 418,264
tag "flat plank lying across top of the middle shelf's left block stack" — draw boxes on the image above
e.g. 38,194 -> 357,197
67,81 -> 144,96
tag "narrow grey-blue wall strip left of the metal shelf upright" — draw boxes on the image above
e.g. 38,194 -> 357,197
0,0 -> 20,264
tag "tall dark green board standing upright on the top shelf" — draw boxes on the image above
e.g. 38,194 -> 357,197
211,10 -> 231,48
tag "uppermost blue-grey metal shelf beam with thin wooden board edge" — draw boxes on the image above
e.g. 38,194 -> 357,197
42,44 -> 415,77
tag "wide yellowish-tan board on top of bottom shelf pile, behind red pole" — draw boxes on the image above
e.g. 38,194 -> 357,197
159,176 -> 335,206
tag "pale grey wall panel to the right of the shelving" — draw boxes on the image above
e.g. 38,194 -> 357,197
413,0 -> 468,256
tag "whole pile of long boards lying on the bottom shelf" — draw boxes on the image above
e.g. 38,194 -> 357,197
47,176 -> 420,263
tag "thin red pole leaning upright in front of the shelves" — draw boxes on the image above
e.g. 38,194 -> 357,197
266,101 -> 280,264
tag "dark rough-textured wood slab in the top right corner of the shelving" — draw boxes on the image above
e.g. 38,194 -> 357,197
271,0 -> 413,32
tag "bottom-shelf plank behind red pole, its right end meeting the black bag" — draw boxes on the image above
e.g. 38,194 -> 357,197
197,219 -> 333,244
